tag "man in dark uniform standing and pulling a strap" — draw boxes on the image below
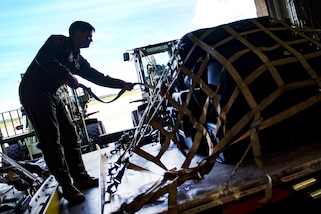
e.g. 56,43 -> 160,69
19,21 -> 133,205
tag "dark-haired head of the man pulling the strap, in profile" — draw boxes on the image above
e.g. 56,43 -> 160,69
69,21 -> 95,49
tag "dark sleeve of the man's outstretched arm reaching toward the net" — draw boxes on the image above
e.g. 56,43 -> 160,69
73,56 -> 125,88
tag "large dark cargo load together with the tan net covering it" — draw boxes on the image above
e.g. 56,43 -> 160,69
108,17 -> 321,213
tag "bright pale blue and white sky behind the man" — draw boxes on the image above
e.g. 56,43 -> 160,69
0,0 -> 256,112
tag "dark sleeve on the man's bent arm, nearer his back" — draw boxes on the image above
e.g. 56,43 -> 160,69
36,35 -> 70,82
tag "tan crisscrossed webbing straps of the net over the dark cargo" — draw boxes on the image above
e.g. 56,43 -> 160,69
110,18 -> 321,213
